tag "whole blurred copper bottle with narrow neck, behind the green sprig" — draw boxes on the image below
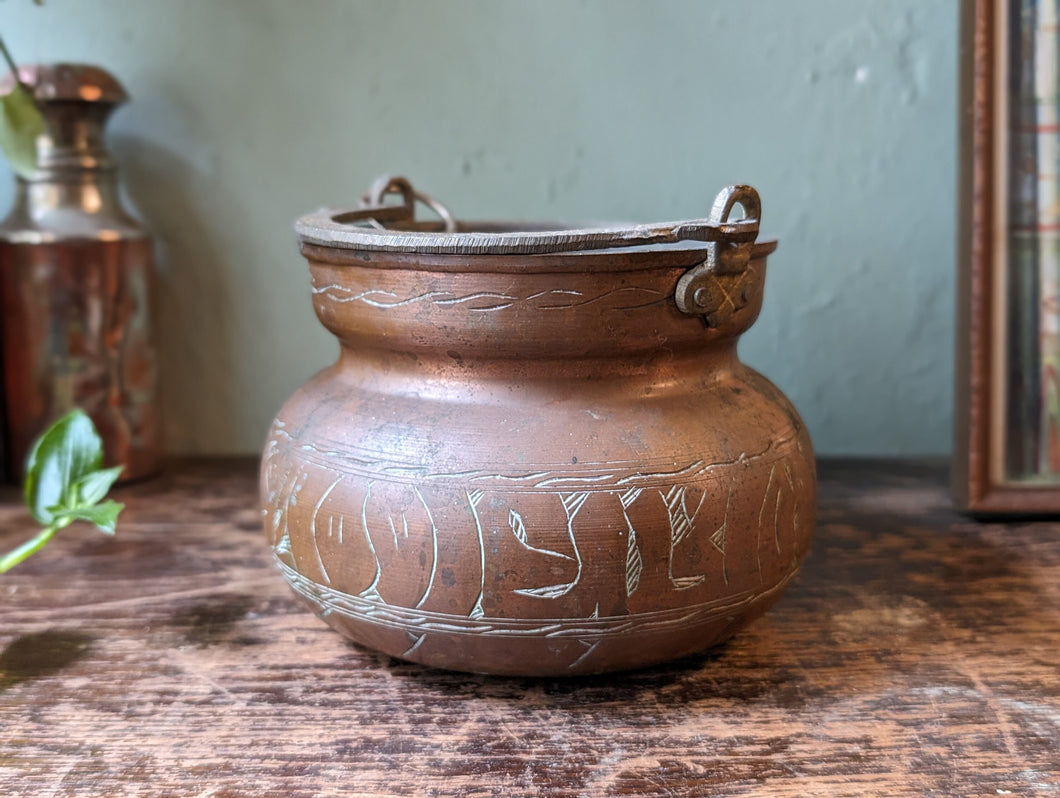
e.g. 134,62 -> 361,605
0,64 -> 158,479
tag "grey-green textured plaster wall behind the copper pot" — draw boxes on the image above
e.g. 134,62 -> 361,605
0,0 -> 957,455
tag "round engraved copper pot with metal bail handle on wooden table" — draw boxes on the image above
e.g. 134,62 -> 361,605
261,178 -> 815,675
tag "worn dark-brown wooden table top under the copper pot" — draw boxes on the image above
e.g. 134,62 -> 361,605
0,460 -> 1060,798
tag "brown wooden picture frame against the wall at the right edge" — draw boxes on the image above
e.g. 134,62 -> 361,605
953,0 -> 1060,515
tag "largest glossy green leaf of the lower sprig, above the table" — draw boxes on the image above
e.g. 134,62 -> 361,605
25,410 -> 103,525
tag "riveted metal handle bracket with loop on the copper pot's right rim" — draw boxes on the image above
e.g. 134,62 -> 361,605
674,185 -> 762,326
